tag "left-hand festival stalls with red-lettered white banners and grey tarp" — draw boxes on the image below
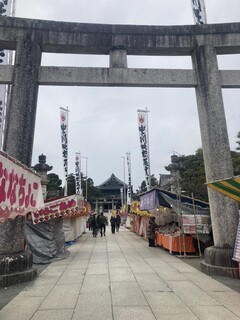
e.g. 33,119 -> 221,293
0,152 -> 91,263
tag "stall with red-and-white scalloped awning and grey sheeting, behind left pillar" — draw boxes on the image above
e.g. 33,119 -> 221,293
26,195 -> 91,263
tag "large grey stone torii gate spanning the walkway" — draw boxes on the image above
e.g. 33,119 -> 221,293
0,17 -> 240,284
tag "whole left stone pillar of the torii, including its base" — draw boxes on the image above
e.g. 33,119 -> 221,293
0,36 -> 41,287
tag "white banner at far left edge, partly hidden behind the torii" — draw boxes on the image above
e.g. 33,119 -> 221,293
0,0 -> 14,149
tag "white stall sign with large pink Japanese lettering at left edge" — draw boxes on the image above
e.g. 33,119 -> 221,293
0,152 -> 44,222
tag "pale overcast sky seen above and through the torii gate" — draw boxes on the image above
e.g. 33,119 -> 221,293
15,0 -> 240,191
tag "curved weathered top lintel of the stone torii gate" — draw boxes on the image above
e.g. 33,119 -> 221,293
0,17 -> 240,56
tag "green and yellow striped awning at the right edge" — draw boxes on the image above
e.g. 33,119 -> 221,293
207,176 -> 240,202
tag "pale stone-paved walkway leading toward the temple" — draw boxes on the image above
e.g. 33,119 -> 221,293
0,228 -> 240,320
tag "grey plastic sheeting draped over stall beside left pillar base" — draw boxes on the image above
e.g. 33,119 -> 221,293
26,218 -> 69,264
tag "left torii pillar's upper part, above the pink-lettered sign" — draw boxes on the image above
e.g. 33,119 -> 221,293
3,36 -> 41,167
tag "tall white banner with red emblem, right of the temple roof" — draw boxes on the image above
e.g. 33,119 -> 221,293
137,110 -> 151,190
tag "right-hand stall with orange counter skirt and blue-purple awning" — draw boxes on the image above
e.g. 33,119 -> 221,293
137,188 -> 211,253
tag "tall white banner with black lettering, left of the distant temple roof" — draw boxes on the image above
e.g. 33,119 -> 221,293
60,108 -> 69,196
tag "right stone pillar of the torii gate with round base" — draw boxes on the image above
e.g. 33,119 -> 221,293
192,45 -> 239,277
